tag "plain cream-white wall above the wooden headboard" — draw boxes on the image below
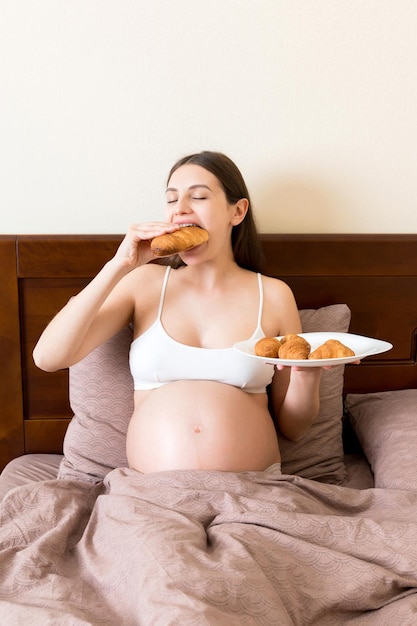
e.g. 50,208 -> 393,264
0,0 -> 417,234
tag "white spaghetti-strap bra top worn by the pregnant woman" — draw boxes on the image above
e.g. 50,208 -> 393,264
129,266 -> 274,393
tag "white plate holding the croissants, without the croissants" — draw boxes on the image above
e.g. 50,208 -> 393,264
233,333 -> 392,367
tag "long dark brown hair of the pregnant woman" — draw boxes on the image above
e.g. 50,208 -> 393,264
168,150 -> 263,272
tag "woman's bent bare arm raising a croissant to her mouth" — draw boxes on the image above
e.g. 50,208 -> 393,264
33,222 -> 178,372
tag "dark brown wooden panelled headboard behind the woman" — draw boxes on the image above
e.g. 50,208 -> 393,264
0,235 -> 417,469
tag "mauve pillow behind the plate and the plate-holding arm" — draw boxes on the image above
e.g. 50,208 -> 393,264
280,304 -> 351,484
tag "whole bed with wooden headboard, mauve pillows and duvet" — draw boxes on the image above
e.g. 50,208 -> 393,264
0,234 -> 417,626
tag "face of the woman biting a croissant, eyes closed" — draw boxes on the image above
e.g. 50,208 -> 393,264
166,164 -> 247,235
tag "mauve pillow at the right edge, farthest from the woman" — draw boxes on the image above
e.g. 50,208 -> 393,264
346,389 -> 417,489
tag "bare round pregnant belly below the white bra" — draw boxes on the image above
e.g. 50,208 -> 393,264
127,381 -> 280,473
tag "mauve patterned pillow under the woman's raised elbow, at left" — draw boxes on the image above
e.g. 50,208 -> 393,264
58,327 -> 133,482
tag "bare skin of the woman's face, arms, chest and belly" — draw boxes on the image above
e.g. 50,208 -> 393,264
34,165 -> 321,472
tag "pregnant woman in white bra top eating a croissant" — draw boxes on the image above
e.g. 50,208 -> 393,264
34,152 -> 322,473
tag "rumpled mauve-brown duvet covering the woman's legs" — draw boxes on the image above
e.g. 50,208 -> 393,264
0,468 -> 417,626
